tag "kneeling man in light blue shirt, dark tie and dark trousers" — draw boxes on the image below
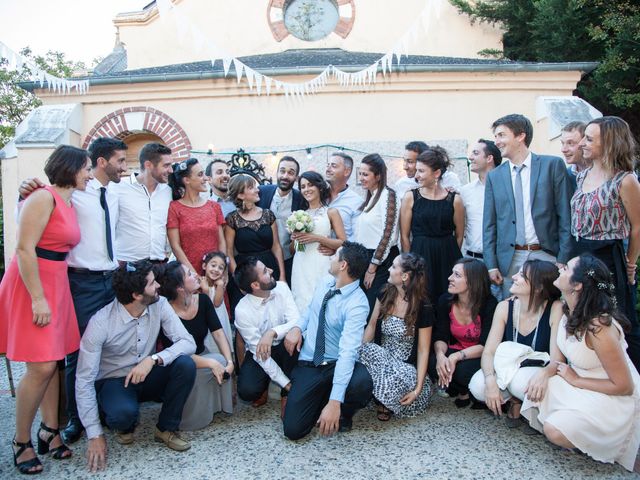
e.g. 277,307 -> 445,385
282,241 -> 373,440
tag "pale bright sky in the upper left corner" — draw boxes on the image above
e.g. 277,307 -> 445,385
0,0 -> 146,66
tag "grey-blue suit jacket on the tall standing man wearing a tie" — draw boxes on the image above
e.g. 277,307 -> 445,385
482,153 -> 573,275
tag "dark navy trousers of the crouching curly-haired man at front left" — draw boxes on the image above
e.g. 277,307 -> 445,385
95,355 -> 196,433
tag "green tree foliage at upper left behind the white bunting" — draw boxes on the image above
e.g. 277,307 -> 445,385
0,47 -> 86,148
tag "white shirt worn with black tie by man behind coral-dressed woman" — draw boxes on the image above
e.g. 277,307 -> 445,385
67,178 -> 118,271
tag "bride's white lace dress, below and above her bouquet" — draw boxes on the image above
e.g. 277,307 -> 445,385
291,207 -> 331,314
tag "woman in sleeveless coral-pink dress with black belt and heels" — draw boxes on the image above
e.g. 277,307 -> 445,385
0,145 -> 93,474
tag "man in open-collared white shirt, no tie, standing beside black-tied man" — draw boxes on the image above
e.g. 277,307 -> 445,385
116,143 -> 172,262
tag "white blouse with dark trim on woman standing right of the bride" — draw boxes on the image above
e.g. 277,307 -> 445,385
354,187 -> 400,265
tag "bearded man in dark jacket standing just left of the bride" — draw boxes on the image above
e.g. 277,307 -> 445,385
258,156 -> 306,286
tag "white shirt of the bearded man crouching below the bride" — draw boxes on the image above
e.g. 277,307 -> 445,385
235,282 -> 300,388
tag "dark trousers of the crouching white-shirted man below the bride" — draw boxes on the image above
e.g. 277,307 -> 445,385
238,342 -> 298,402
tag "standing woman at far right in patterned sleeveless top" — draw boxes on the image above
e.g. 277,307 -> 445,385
571,117 -> 640,370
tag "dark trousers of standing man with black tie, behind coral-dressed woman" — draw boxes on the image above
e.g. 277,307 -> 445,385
64,272 -> 115,422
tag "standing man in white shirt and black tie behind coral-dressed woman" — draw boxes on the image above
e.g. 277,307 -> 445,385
20,137 -> 128,443
